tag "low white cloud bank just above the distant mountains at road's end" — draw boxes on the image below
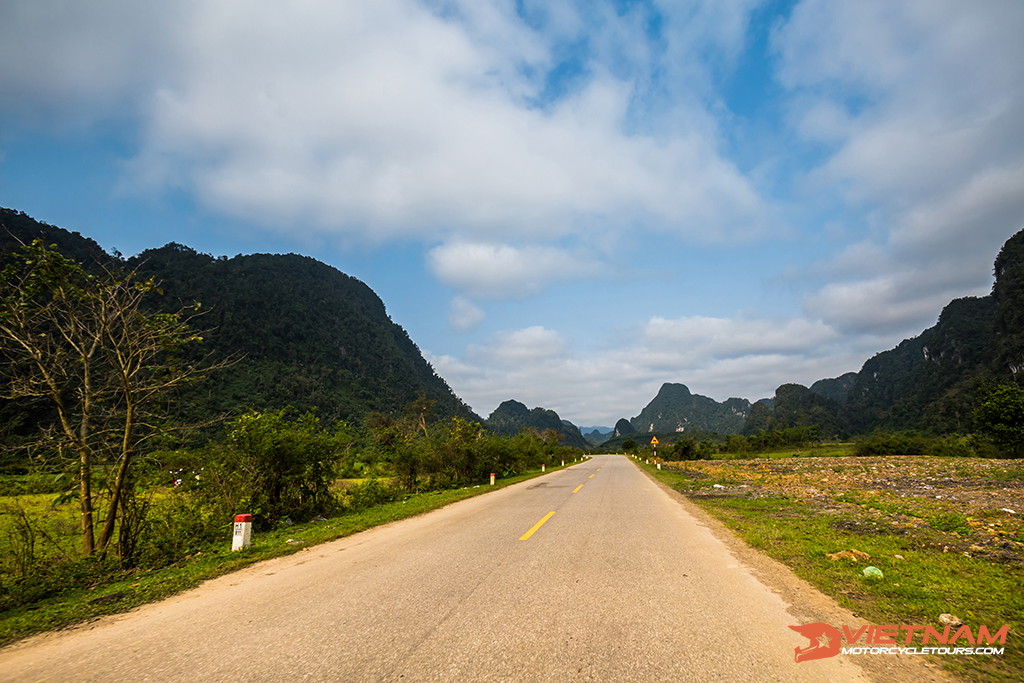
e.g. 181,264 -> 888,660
428,316 -> 856,426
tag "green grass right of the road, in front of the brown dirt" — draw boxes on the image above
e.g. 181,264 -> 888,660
641,462 -> 1024,681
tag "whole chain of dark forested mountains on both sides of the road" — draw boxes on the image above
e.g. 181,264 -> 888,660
8,209 -> 1024,449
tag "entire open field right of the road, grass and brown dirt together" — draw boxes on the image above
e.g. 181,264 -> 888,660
640,451 -> 1024,681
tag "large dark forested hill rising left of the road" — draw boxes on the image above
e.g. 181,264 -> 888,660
0,210 -> 481,444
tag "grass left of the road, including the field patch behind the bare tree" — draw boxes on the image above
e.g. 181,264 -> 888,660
0,467 -> 577,645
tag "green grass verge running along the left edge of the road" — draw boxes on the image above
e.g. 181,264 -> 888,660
0,466 -> 577,645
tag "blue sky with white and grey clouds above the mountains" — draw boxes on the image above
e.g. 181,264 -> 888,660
0,0 -> 1024,426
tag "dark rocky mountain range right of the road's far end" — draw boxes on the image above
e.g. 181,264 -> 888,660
614,230 -> 1024,436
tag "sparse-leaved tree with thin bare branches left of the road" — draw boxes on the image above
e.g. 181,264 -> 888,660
0,240 -> 218,556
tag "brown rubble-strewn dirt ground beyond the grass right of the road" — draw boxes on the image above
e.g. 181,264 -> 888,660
669,456 -> 1024,563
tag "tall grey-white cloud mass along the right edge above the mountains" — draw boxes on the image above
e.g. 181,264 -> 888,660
775,0 -> 1024,335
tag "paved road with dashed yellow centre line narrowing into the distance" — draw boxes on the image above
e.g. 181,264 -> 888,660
0,456 -> 941,682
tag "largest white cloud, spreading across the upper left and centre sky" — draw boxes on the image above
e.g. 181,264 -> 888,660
110,0 -> 765,242
